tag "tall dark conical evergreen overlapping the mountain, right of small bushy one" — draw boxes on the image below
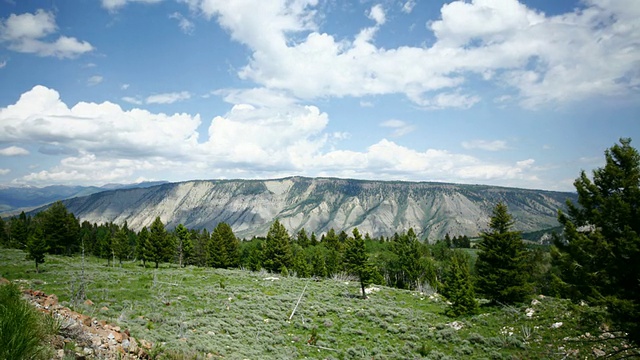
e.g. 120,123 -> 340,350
476,202 -> 529,304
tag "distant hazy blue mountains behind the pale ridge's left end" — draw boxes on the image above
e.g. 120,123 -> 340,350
0,181 -> 166,215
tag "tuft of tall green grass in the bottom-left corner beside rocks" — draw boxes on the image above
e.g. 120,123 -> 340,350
0,284 -> 55,360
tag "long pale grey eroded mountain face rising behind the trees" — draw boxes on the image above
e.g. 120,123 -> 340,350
65,177 -> 575,240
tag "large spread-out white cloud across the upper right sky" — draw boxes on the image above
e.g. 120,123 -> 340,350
185,0 -> 640,109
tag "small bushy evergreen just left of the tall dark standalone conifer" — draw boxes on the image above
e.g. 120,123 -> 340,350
444,250 -> 478,316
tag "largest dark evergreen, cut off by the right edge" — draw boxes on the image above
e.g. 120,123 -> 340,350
552,138 -> 640,345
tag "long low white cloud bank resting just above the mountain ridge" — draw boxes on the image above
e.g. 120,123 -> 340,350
0,86 -> 536,185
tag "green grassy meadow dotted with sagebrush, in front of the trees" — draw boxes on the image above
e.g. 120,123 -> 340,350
0,249 -> 625,359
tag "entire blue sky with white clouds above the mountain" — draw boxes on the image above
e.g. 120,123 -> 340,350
0,0 -> 640,191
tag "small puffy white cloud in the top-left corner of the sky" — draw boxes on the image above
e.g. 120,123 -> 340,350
0,10 -> 93,58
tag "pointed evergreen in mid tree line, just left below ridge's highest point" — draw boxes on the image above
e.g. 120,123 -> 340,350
263,219 -> 293,272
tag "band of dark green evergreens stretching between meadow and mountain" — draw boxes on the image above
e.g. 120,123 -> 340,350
0,139 -> 640,344
